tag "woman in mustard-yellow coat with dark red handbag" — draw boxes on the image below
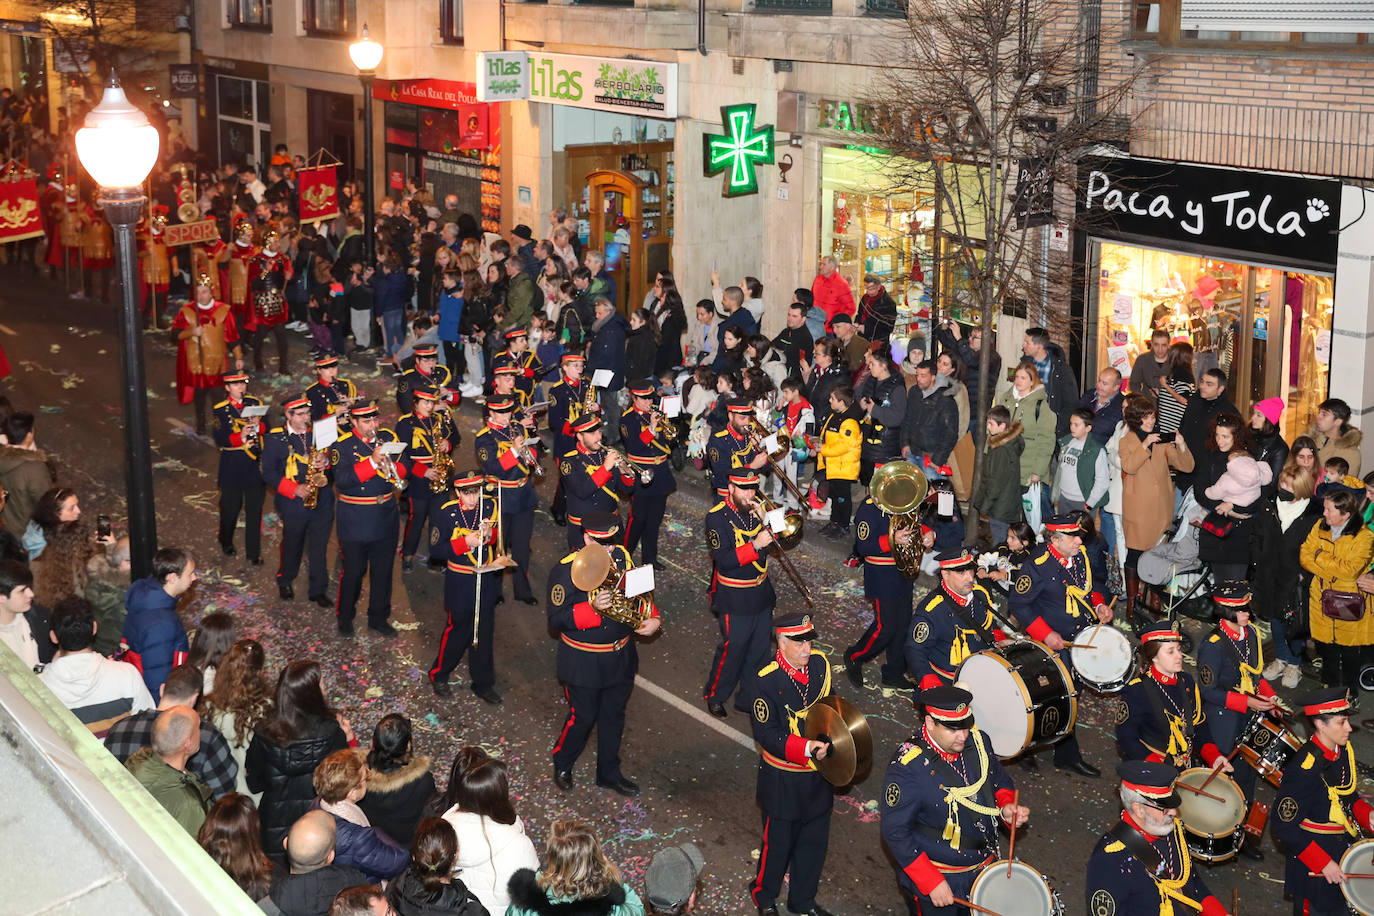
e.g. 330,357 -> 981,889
1300,488 -> 1374,702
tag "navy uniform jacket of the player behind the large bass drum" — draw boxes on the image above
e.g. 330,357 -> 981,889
905,582 -> 1006,689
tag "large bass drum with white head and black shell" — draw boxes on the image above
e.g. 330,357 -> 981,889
955,640 -> 1079,759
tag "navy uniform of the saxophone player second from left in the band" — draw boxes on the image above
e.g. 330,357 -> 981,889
262,427 -> 334,599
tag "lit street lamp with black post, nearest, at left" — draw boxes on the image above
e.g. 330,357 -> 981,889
76,80 -> 161,580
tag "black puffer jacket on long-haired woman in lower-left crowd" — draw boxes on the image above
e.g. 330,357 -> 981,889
243,720 -> 348,862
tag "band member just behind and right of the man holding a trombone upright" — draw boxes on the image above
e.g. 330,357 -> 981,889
473,396 -> 539,604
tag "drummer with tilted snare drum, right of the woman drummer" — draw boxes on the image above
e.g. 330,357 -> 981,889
1197,582 -> 1278,860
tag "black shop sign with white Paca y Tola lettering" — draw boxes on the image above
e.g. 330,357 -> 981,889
1077,157 -> 1341,272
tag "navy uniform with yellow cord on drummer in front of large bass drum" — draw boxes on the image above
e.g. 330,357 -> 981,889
879,726 -> 1013,916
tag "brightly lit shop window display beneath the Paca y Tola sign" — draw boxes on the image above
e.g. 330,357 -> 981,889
1094,242 -> 1333,438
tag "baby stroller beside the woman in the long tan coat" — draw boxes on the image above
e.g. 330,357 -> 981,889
1132,490 -> 1213,652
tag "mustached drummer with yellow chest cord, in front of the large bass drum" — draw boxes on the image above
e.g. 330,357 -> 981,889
879,684 -> 1031,916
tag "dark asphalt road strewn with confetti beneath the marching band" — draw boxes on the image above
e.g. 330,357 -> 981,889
0,266 -> 1371,916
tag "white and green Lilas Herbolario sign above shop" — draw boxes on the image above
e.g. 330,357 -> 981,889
477,51 -> 677,119
